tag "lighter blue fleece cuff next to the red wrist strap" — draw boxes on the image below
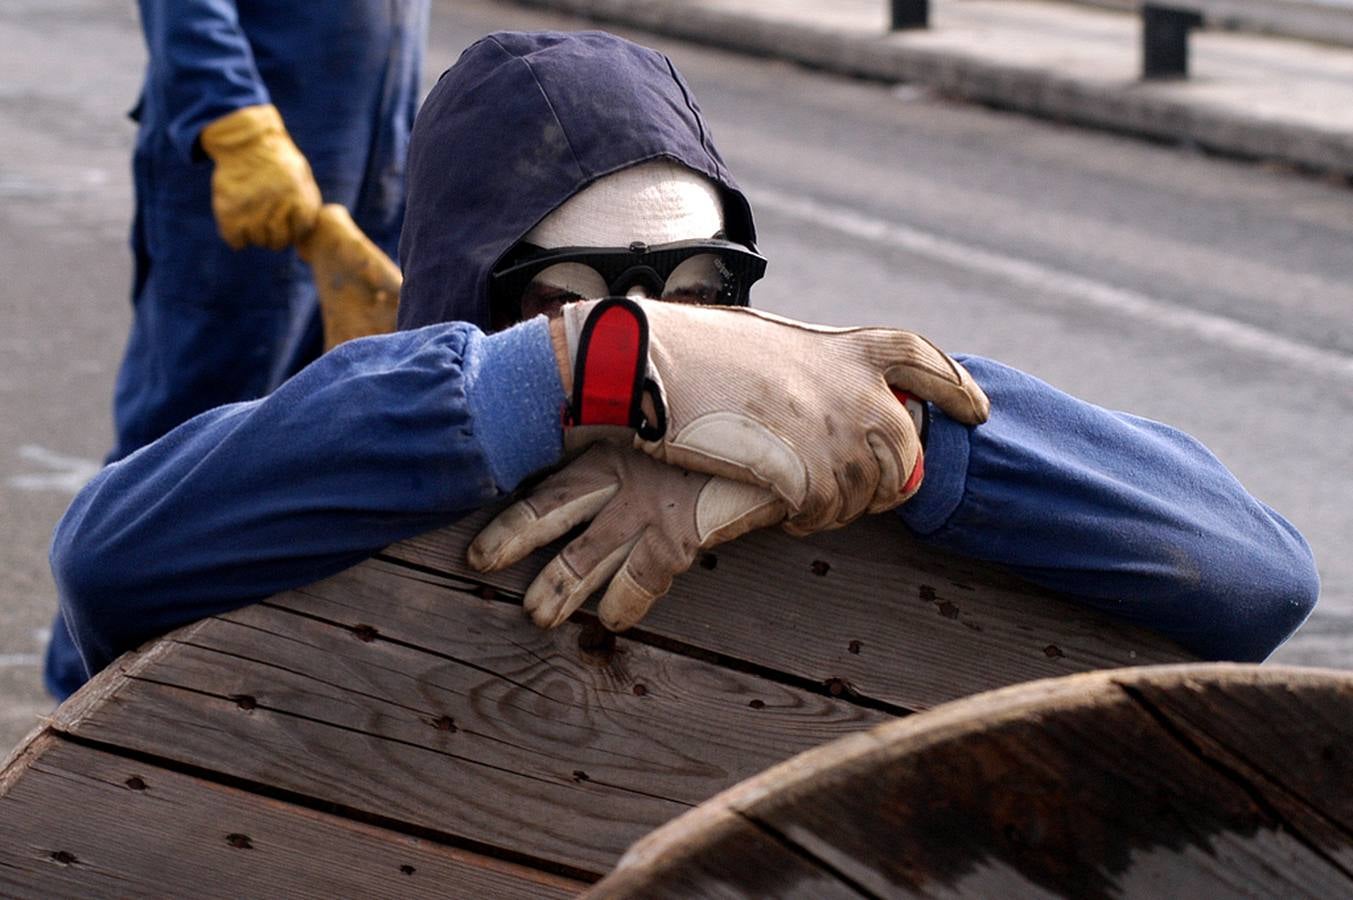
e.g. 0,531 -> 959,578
465,315 -> 566,493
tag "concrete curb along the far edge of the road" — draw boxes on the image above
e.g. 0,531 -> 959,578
515,0 -> 1353,177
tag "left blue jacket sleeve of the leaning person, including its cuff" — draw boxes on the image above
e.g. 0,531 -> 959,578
51,318 -> 564,674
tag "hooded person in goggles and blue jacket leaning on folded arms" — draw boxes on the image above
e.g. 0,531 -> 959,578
51,32 -> 1315,703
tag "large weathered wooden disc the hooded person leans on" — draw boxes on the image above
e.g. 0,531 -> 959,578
0,506 -> 1206,897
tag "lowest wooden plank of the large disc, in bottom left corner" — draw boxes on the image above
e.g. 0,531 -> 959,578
0,734 -> 584,899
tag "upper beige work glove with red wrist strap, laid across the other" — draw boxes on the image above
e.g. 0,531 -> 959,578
551,298 -> 989,535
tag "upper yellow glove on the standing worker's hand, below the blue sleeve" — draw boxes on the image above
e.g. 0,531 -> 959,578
200,103 -> 321,250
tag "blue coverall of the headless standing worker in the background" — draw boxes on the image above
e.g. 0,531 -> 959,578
45,0 -> 428,689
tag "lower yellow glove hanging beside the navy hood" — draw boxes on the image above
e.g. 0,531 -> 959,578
296,203 -> 403,351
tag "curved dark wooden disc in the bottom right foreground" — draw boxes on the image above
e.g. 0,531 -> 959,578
587,665 -> 1353,899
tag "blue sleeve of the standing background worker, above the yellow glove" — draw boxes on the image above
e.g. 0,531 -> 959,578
141,0 -> 271,161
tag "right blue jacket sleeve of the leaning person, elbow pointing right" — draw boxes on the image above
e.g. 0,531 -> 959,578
900,357 -> 1319,662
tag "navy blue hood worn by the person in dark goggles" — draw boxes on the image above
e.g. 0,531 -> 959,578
399,31 -> 756,335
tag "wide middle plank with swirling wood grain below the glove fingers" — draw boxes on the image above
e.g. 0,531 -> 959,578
57,562 -> 888,876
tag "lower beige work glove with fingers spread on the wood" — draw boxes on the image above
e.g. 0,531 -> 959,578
467,443 -> 786,631
